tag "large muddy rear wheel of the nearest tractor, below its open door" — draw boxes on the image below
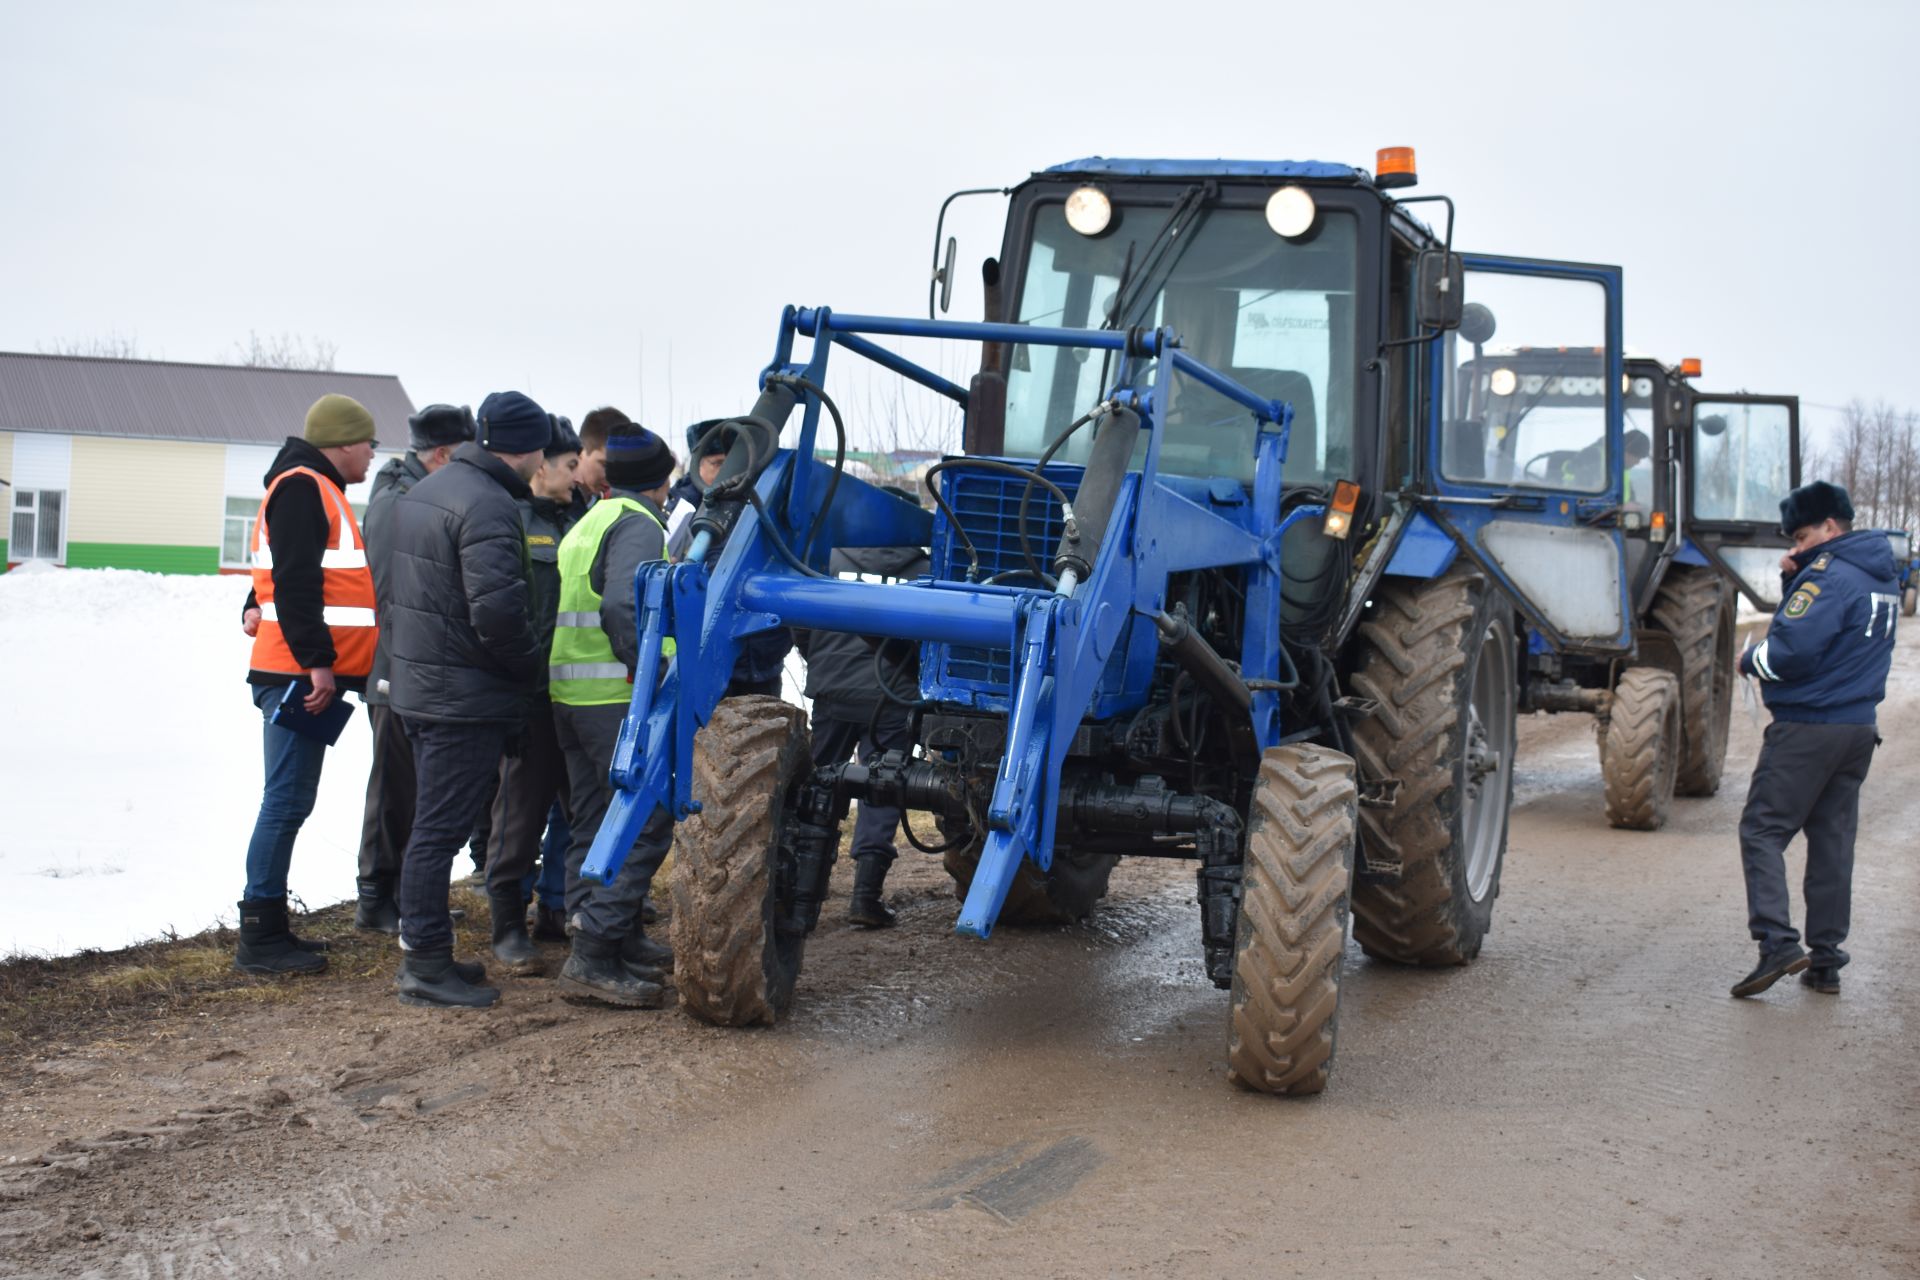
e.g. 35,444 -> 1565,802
1352,566 -> 1519,965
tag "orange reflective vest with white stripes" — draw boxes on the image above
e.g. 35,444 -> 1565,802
252,466 -> 378,676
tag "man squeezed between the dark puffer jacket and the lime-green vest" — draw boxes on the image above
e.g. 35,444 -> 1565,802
486,416 -> 588,973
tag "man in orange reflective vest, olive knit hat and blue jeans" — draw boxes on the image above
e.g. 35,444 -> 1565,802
234,395 -> 374,973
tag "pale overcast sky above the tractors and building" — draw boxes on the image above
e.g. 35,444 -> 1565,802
0,0 -> 1920,460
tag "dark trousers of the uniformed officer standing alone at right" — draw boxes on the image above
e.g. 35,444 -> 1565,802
1740,720 -> 1876,969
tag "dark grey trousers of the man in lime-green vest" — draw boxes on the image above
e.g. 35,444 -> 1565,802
553,702 -> 674,940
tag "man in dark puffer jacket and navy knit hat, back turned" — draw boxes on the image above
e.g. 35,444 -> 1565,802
386,391 -> 553,1007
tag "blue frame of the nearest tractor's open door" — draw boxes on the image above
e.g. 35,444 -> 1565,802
1420,253 -> 1634,654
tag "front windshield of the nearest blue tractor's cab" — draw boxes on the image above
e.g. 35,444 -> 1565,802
1004,201 -> 1357,484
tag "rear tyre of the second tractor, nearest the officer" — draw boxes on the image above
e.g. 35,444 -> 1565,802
1643,564 -> 1736,794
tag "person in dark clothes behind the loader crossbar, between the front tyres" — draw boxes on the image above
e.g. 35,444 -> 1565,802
795,547 -> 929,929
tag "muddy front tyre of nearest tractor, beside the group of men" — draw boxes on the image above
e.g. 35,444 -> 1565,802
672,697 -> 812,1027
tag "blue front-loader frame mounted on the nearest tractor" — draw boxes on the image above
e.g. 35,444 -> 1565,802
584,307 -> 1323,938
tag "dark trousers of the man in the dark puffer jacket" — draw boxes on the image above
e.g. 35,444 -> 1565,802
399,720 -> 507,950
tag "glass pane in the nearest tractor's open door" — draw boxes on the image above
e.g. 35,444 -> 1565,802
1442,271 -> 1620,503
